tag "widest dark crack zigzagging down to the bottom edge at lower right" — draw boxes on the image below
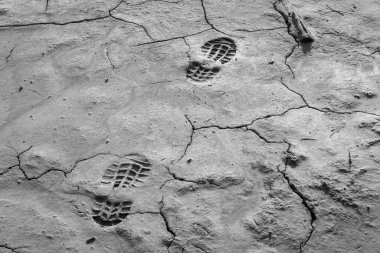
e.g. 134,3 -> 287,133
277,163 -> 317,253
